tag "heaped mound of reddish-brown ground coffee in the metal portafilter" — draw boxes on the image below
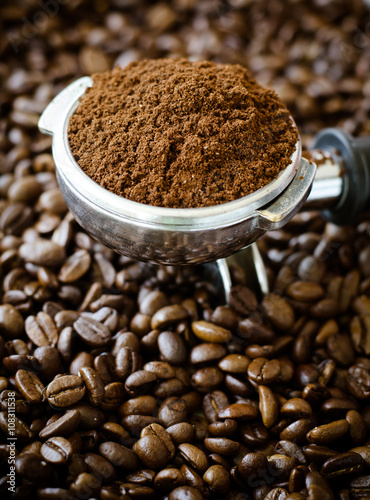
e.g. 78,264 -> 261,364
69,58 -> 298,208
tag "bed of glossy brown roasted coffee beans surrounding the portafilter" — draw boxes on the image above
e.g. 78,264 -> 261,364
0,0 -> 370,500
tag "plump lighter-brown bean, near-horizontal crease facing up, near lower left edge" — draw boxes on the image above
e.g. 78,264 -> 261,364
45,375 -> 86,408
